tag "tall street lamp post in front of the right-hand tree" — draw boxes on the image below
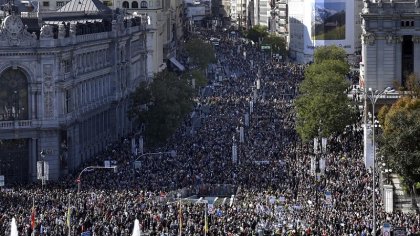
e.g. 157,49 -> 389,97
363,87 -> 391,235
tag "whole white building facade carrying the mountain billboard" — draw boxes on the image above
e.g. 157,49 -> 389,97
288,0 -> 363,63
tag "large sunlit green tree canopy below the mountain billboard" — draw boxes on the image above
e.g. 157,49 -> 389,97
295,46 -> 357,141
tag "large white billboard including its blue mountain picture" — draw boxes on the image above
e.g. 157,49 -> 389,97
303,0 -> 356,58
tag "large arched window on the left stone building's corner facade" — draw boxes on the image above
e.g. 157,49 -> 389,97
0,68 -> 28,121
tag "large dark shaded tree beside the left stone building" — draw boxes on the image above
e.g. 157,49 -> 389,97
129,71 -> 193,146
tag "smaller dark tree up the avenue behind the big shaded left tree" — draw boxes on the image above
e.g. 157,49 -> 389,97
185,38 -> 216,69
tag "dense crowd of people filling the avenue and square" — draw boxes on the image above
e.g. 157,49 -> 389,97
0,27 -> 420,236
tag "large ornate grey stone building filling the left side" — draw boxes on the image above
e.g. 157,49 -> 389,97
0,0 -> 147,184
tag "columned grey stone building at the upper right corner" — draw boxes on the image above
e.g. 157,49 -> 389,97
360,0 -> 420,90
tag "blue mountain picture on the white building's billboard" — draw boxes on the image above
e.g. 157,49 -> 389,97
311,1 -> 346,40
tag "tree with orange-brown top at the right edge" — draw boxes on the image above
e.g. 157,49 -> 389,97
379,97 -> 420,197
